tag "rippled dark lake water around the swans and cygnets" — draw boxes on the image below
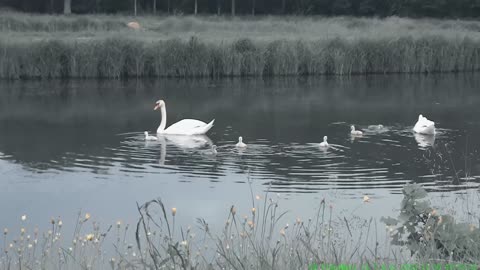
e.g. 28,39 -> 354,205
0,74 -> 480,236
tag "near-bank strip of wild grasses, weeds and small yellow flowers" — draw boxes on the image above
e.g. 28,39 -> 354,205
0,185 -> 480,270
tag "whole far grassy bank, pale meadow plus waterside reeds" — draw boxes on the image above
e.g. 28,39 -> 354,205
0,13 -> 480,79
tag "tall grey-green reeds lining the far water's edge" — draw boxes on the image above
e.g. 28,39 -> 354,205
0,37 -> 480,79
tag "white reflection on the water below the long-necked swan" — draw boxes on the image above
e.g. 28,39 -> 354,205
150,134 -> 213,166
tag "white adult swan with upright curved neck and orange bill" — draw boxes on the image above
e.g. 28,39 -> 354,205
153,100 -> 215,135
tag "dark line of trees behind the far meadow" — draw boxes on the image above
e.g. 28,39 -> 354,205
0,0 -> 480,18
